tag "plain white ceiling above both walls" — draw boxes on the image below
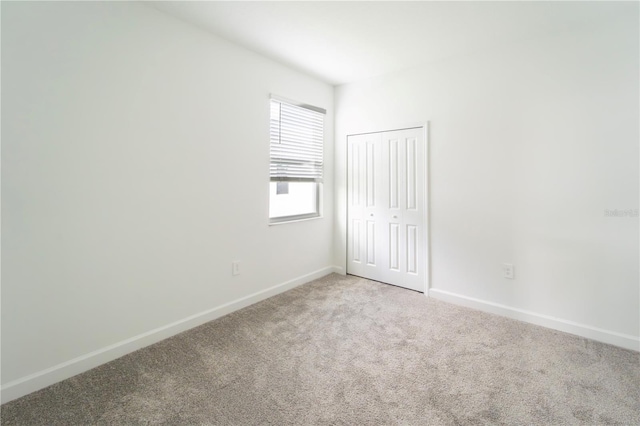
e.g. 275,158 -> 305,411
147,1 -> 637,85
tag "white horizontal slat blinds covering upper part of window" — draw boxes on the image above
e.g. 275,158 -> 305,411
271,97 -> 325,182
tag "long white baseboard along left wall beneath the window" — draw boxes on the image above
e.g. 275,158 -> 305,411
0,266 -> 342,404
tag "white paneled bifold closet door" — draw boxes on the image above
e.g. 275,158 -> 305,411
347,128 -> 426,291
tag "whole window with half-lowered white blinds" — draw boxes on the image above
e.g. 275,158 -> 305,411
269,96 -> 326,223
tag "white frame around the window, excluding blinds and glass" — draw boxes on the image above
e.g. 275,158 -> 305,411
268,94 -> 327,225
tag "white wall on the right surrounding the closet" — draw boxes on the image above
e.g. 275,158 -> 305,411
335,9 -> 640,349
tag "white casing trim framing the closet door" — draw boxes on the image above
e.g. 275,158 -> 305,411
344,121 -> 431,297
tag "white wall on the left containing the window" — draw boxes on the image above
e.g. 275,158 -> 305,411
2,2 -> 334,400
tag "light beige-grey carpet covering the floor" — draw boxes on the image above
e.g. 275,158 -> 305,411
1,274 -> 640,425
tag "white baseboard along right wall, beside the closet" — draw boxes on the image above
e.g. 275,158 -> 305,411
429,288 -> 640,351
